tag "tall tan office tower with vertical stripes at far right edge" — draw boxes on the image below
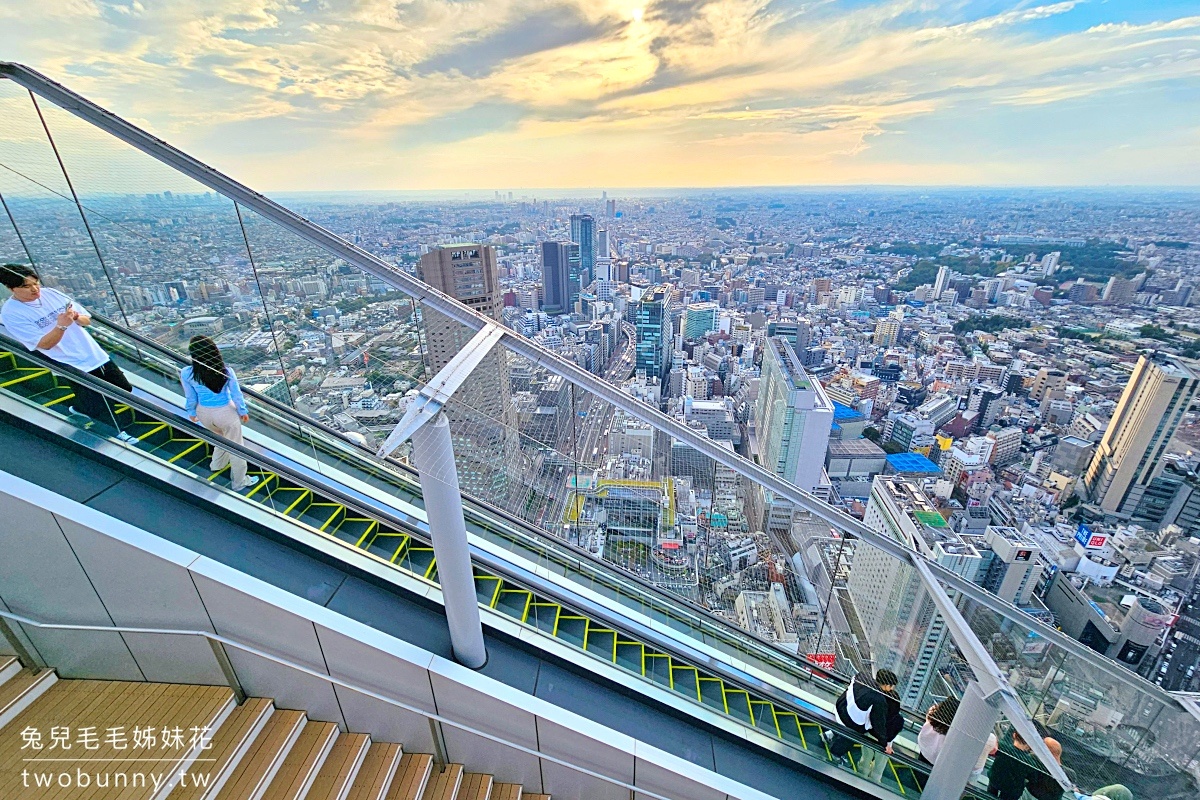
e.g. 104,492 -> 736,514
1084,356 -> 1200,513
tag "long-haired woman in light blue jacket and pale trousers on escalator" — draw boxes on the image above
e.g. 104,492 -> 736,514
179,336 -> 258,492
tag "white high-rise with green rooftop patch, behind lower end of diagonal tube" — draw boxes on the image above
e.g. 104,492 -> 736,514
846,475 -> 983,708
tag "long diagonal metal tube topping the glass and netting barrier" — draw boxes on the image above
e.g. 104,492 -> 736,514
0,61 -> 1166,709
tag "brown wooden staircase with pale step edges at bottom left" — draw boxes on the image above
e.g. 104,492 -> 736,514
0,656 -> 550,800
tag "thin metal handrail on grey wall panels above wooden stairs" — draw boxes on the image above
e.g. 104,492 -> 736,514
0,609 -> 678,800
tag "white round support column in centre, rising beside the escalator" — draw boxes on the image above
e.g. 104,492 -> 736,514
412,414 -> 487,669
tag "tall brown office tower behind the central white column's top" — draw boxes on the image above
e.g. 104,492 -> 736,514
416,243 -> 520,500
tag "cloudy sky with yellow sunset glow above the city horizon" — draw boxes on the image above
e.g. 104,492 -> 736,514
0,0 -> 1200,192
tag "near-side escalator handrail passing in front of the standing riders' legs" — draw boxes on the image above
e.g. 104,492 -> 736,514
0,333 -> 970,788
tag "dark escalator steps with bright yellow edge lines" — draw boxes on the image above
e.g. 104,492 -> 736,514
0,328 -> 964,796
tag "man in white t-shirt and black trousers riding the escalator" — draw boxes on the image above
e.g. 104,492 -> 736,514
0,264 -> 133,441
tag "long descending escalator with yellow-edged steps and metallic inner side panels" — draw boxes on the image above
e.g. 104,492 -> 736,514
0,325 -> 974,796
